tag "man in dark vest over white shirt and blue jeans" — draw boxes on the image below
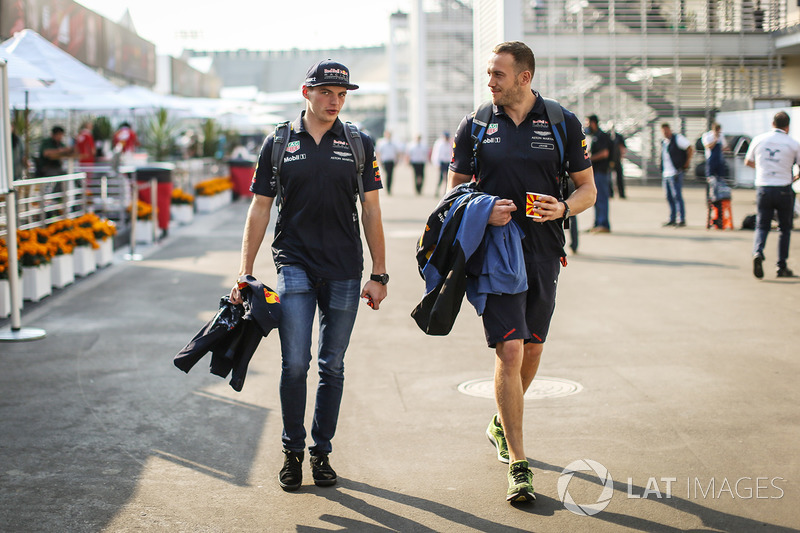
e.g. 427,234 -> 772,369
661,122 -> 694,227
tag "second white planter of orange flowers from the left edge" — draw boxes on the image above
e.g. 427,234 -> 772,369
17,228 -> 53,302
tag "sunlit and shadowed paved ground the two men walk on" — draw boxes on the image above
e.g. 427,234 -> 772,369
0,169 -> 800,532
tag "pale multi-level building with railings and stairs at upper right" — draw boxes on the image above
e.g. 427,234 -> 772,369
474,0 -> 800,177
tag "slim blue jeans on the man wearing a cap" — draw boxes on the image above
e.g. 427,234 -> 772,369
278,265 -> 361,455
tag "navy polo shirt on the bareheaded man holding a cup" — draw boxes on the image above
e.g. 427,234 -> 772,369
450,91 -> 592,261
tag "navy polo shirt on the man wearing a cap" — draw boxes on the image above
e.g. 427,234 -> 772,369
250,112 -> 382,280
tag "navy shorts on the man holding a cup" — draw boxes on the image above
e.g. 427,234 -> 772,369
482,258 -> 561,348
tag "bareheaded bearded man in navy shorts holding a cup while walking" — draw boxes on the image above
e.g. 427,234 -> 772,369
448,41 -> 597,502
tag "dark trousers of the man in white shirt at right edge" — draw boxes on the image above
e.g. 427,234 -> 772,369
753,185 -> 794,268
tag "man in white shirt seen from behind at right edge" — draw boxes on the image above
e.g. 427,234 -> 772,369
744,111 -> 800,279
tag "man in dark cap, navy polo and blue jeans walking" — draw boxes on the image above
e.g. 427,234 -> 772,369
231,59 -> 389,491
